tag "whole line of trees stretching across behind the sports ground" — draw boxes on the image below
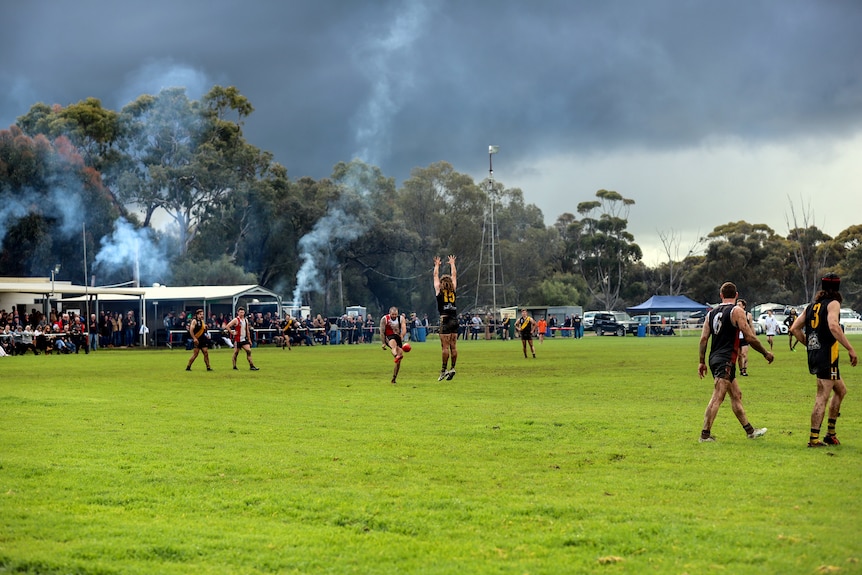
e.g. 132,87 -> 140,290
0,86 -> 862,317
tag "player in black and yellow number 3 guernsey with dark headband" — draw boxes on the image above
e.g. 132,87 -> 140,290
790,273 -> 859,447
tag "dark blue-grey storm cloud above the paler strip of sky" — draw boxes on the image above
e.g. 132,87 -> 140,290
0,0 -> 862,184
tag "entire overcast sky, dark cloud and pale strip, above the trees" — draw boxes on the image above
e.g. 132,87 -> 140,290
0,0 -> 862,265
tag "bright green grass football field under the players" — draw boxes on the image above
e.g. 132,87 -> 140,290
0,336 -> 862,575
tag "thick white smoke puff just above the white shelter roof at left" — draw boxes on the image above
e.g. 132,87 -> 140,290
93,218 -> 168,285
